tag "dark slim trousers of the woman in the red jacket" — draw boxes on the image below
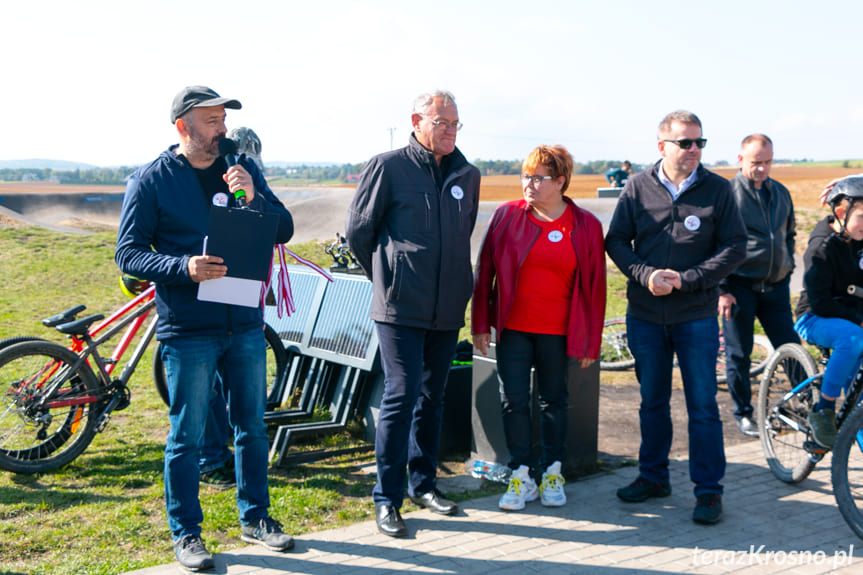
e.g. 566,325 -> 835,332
496,329 -> 569,471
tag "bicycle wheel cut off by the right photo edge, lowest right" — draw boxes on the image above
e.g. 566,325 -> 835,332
830,405 -> 863,538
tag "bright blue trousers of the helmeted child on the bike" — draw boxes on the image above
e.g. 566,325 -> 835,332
794,313 -> 863,397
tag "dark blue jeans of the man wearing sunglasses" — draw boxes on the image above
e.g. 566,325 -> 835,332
626,316 -> 725,496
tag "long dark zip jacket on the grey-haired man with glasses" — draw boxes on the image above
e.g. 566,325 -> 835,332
345,134 -> 480,330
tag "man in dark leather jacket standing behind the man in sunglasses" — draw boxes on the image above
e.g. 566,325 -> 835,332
719,134 -> 800,437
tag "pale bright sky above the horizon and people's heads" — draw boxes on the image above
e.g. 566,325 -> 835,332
0,0 -> 863,166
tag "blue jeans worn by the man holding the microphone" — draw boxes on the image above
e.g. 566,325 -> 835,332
162,329 -> 270,541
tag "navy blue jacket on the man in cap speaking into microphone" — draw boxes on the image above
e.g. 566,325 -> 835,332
114,146 -> 294,339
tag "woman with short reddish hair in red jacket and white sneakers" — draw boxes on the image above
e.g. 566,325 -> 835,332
471,146 -> 605,511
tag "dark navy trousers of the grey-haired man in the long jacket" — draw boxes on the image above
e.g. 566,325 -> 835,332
372,322 -> 458,509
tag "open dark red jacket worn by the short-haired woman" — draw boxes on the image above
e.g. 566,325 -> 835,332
471,196 -> 605,359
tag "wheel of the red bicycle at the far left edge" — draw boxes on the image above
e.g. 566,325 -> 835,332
0,341 -> 101,474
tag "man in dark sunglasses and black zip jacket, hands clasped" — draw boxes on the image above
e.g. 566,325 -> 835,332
605,110 -> 746,524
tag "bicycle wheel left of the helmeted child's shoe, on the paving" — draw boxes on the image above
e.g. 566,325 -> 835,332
755,343 -> 818,483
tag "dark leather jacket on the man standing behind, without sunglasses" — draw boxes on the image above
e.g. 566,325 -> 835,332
720,172 -> 797,291
